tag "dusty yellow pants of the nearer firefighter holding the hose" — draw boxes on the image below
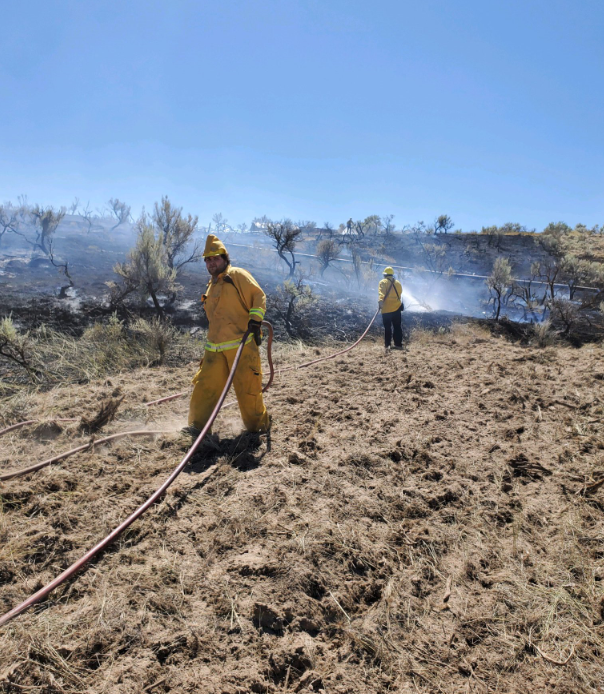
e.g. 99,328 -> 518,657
189,340 -> 269,431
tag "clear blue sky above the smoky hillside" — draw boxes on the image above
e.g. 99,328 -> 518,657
0,0 -> 604,231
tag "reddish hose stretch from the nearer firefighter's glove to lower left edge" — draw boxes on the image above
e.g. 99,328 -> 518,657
0,330 -> 250,626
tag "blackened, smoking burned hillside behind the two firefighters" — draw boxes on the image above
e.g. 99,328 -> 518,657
0,209 -> 604,342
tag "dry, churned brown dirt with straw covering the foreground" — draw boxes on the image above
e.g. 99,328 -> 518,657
0,324 -> 604,694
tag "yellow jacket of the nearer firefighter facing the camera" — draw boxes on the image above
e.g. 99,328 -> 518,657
201,265 -> 266,352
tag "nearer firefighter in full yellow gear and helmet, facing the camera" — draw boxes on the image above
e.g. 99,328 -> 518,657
189,234 -> 269,438
